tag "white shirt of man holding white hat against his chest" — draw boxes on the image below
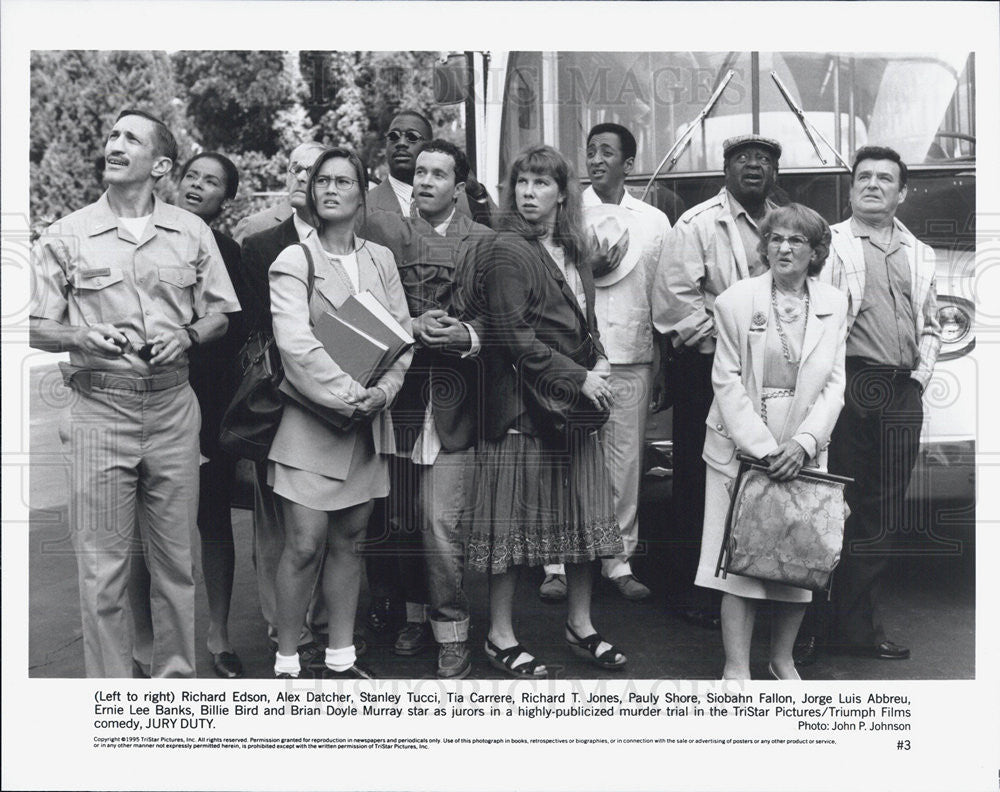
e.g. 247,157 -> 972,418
582,186 -> 670,365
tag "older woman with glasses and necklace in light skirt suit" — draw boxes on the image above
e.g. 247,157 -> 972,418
695,203 -> 847,679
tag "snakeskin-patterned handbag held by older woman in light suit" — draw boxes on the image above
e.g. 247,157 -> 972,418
715,454 -> 853,591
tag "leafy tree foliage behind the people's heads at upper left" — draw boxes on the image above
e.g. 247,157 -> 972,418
30,50 -> 463,231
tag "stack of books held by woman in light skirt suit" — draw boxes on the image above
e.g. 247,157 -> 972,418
281,291 -> 413,429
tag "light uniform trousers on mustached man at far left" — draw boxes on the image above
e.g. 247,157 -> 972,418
60,383 -> 201,677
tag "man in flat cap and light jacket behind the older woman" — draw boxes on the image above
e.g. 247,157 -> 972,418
653,135 -> 781,628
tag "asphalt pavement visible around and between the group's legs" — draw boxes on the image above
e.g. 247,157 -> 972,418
25,368 -> 975,680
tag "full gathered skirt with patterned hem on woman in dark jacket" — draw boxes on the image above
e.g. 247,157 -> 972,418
463,432 -> 622,574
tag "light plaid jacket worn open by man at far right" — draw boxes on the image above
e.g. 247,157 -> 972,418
819,219 -> 941,388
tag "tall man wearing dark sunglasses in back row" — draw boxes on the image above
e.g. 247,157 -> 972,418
368,110 -> 496,225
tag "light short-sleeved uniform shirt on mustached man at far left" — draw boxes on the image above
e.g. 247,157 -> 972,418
31,193 -> 240,376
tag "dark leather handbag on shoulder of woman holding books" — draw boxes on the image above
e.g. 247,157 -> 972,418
219,242 -> 316,462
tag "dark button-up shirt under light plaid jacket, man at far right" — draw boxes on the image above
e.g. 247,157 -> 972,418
847,217 -> 918,369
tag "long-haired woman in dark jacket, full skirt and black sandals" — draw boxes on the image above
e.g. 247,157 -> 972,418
467,146 -> 626,678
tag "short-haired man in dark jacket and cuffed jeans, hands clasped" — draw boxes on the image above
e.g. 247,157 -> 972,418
362,140 -> 494,679
